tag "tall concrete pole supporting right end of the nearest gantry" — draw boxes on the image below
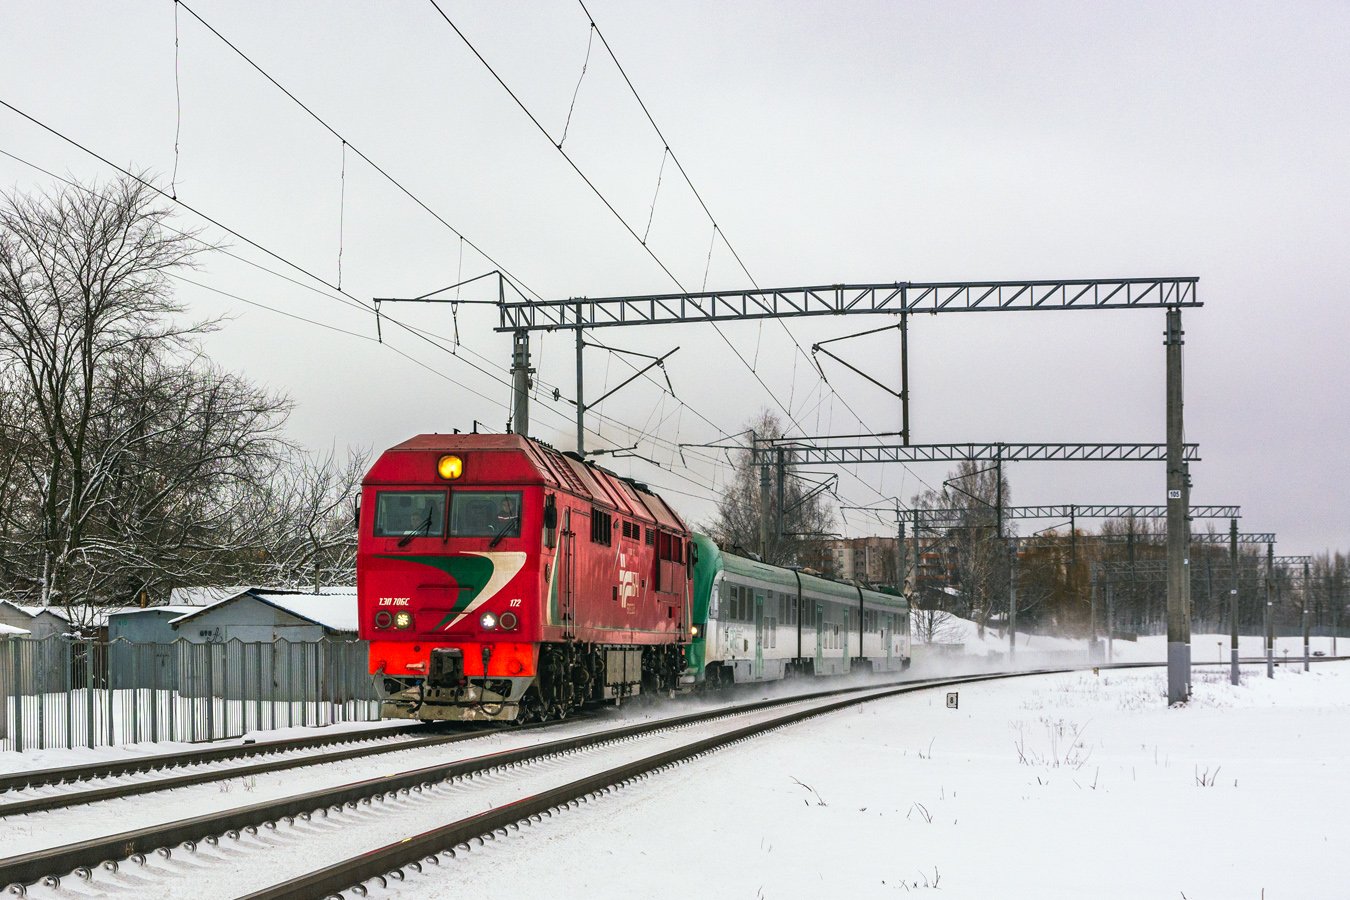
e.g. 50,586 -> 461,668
1164,306 -> 1191,706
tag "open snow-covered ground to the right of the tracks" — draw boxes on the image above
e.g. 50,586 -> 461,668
373,663 -> 1350,900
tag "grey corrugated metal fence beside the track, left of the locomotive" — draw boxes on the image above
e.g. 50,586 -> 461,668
0,636 -> 379,750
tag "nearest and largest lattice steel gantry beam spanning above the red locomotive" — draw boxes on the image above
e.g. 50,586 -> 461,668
497,277 -> 1203,331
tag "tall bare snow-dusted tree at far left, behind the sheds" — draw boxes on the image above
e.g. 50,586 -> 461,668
0,178 -> 289,620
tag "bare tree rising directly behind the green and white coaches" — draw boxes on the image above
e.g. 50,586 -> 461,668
703,410 -> 834,565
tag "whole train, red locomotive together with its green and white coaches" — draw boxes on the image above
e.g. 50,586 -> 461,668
356,434 -> 910,722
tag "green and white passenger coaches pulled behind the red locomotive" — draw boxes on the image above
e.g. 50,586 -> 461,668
684,534 -> 910,685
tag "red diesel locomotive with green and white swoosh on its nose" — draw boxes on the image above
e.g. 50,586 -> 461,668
356,434 -> 691,722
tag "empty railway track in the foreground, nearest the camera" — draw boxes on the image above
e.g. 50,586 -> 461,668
0,657 -> 1330,897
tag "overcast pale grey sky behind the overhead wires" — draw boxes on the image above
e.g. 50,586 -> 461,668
0,0 -> 1350,553
